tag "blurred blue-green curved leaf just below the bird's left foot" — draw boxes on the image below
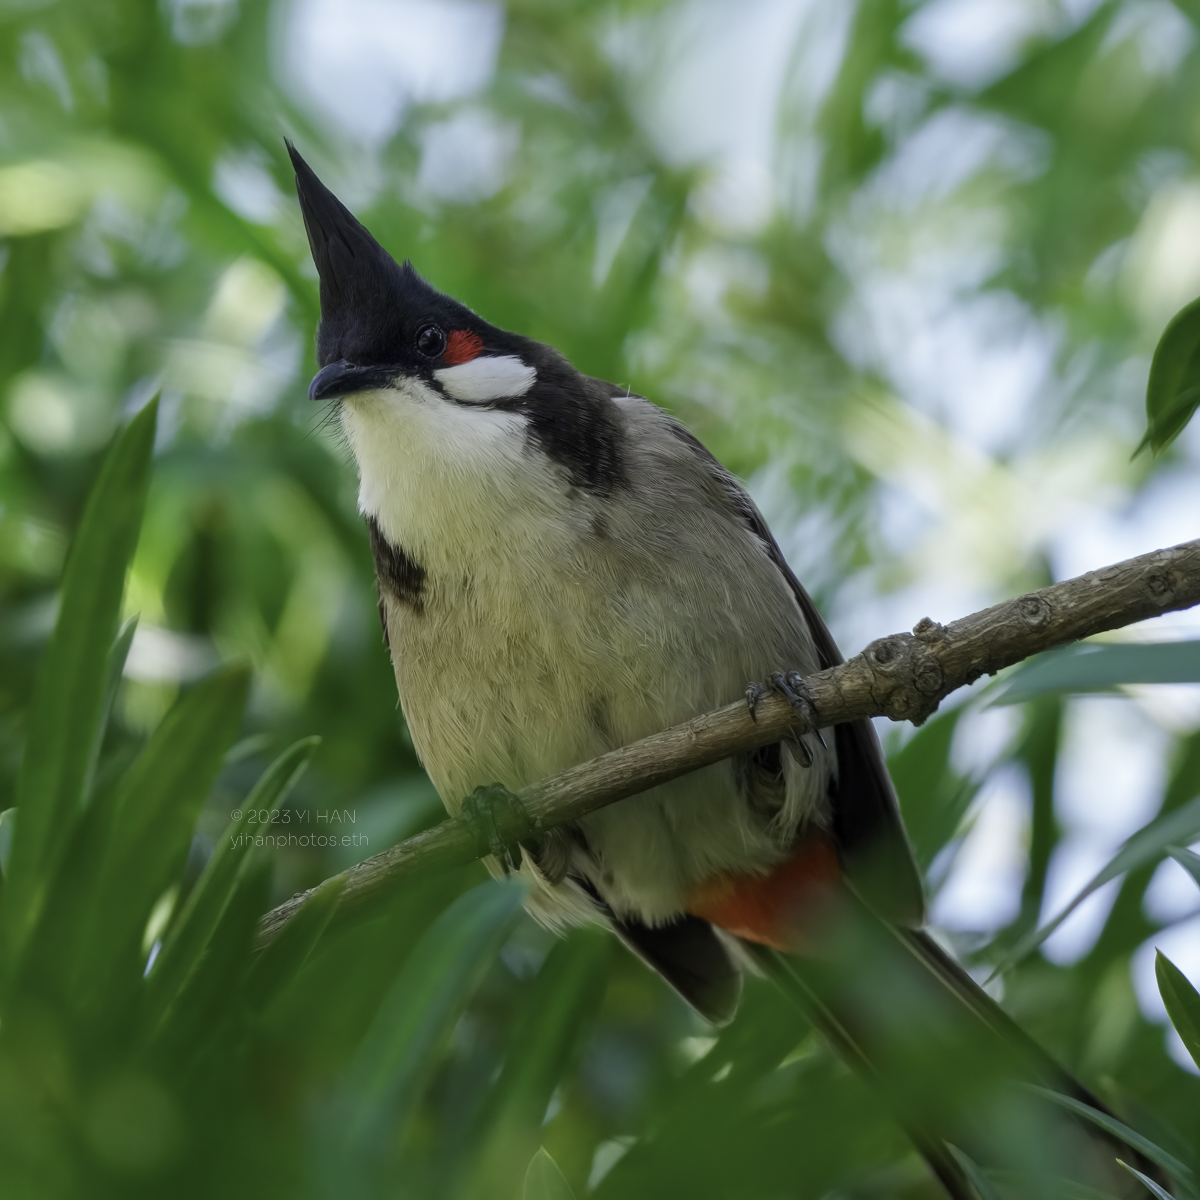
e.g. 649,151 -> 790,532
347,878 -> 526,1146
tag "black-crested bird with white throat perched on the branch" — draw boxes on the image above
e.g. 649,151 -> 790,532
287,143 -> 1171,1196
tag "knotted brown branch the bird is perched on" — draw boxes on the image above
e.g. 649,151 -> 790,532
259,539 -> 1200,944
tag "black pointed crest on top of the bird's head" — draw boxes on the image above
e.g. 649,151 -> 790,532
287,142 -> 436,366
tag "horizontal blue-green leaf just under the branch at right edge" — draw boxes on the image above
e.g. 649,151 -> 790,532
991,642 -> 1200,704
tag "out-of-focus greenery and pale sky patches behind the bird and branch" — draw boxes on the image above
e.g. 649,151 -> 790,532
0,0 -> 1200,1194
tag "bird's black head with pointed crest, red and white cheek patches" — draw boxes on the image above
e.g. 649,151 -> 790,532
288,143 -> 622,491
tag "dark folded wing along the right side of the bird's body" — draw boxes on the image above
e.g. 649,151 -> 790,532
668,419 -> 925,925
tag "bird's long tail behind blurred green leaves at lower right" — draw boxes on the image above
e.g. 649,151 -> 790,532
748,896 -> 1171,1200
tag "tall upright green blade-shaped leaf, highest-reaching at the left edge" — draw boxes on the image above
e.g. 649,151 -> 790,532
0,401 -> 157,972
